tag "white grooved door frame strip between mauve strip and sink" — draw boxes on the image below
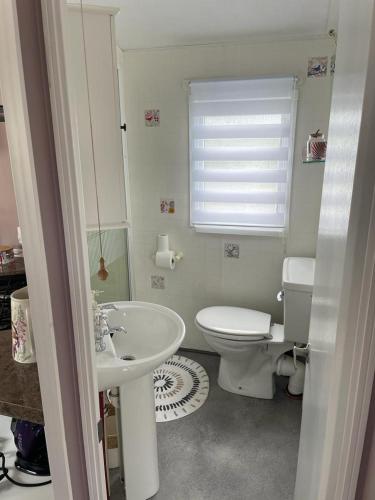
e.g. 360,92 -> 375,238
41,0 -> 105,498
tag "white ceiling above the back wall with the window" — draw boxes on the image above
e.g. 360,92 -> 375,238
67,0 -> 338,49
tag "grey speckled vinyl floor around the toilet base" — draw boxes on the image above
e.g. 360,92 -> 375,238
111,351 -> 302,500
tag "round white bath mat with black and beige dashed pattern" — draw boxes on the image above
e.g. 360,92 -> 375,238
154,355 -> 210,422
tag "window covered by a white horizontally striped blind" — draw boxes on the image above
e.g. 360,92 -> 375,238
189,77 -> 297,232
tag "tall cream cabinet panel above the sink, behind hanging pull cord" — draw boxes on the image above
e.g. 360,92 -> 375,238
69,9 -> 126,227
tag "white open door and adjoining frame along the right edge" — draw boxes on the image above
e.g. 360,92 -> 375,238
295,0 -> 375,500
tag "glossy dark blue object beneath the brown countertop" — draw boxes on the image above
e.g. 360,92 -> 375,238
11,418 -> 50,476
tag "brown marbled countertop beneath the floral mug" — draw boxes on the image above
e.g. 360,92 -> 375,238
0,330 -> 44,424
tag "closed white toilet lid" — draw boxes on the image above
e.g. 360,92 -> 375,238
196,306 -> 271,337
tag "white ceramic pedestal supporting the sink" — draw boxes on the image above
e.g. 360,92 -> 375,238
120,373 -> 159,500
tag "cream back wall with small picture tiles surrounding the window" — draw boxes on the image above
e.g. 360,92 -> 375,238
124,39 -> 334,349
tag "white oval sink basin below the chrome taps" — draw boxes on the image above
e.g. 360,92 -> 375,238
96,301 -> 185,391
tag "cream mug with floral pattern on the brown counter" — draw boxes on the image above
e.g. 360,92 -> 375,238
10,286 -> 36,363
